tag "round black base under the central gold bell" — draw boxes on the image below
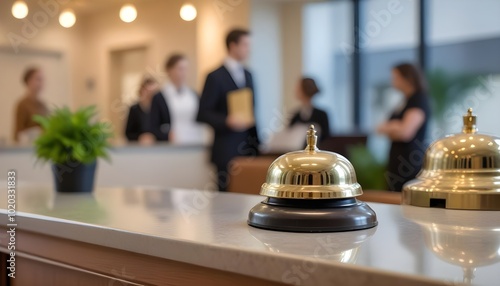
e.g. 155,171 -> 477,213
248,198 -> 378,232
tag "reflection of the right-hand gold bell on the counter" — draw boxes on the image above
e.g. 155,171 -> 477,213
403,207 -> 500,284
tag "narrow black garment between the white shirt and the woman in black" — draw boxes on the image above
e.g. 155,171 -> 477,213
150,91 -> 171,141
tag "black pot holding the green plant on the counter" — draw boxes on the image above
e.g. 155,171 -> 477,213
52,161 -> 97,193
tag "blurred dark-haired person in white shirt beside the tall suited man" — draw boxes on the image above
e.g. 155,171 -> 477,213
151,54 -> 205,144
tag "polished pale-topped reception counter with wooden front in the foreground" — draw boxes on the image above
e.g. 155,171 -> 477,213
0,187 -> 500,286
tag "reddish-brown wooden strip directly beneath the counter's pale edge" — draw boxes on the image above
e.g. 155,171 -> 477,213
0,228 -> 285,286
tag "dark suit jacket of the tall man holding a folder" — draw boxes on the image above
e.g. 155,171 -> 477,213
197,66 -> 259,170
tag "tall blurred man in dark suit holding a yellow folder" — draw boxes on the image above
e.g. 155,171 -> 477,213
198,29 -> 259,192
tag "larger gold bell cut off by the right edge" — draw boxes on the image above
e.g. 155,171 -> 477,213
403,109 -> 500,210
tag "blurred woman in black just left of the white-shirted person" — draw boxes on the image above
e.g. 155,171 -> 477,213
125,78 -> 158,144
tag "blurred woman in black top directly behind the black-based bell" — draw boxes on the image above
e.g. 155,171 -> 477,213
290,78 -> 330,141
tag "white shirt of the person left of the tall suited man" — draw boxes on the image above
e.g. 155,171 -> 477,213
162,83 -> 206,144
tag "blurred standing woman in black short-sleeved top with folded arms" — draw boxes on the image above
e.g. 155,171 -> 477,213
378,63 -> 431,192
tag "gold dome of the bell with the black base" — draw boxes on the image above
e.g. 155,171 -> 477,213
260,125 -> 363,199
